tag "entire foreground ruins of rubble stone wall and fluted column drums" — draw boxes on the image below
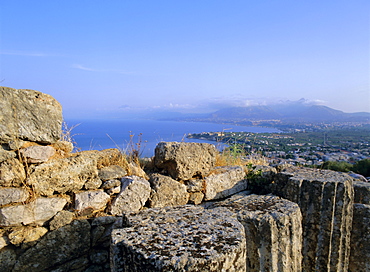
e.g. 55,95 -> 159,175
0,87 -> 370,272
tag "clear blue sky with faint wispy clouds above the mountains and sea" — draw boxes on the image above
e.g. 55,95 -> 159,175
0,0 -> 370,118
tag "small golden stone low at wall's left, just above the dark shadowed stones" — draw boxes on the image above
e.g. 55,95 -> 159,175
8,227 -> 48,248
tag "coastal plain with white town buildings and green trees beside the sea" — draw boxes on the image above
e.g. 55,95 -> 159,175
187,124 -> 370,170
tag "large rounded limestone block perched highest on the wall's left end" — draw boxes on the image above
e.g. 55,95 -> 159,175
0,87 -> 63,144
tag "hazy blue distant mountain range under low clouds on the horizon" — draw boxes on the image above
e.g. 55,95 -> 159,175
163,102 -> 370,123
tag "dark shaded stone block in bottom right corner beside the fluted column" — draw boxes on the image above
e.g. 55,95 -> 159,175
349,204 -> 370,272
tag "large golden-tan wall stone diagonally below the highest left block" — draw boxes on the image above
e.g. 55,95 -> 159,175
27,153 -> 98,196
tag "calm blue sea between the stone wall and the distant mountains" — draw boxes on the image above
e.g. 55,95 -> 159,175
66,119 -> 279,157
